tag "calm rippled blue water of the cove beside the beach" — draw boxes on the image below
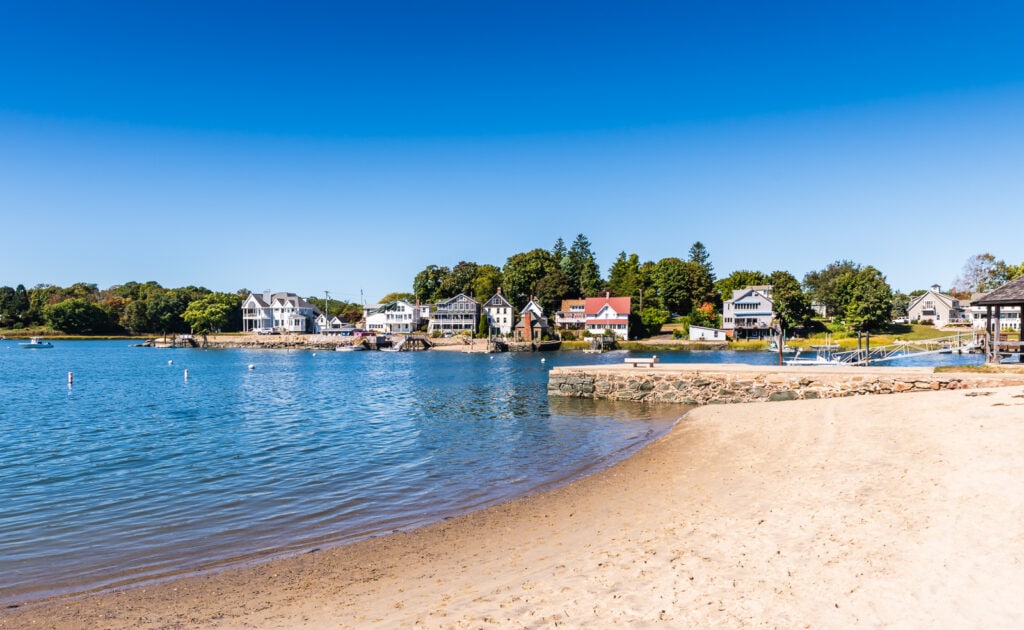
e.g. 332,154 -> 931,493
0,341 -> 980,603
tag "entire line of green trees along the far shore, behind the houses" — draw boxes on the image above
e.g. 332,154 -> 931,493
0,244 -> 1024,335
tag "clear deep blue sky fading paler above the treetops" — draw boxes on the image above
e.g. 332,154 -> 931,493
0,0 -> 1024,302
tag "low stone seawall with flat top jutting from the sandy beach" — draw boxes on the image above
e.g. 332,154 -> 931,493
548,364 -> 1024,405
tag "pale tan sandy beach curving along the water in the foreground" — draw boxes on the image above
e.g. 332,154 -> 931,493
0,387 -> 1024,628
